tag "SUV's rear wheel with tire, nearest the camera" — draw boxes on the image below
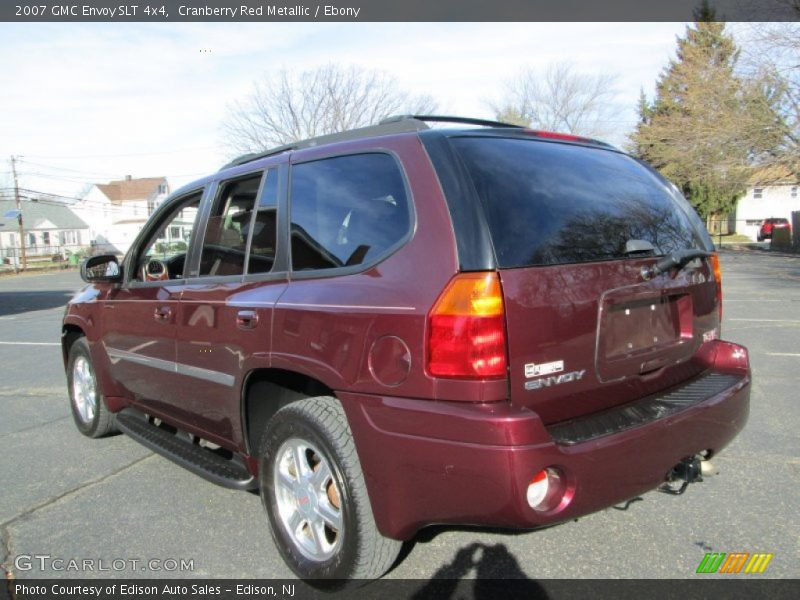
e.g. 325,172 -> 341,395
259,396 -> 402,587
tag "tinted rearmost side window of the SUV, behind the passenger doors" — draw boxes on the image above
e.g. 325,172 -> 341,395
290,153 -> 411,271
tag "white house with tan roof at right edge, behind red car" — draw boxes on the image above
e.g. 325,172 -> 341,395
736,168 -> 800,241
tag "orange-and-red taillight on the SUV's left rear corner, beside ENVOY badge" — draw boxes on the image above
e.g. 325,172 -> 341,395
427,272 -> 507,379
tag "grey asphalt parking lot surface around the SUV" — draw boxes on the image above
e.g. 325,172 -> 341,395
0,251 -> 800,580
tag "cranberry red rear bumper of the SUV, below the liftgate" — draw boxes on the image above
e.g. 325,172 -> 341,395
339,341 -> 750,539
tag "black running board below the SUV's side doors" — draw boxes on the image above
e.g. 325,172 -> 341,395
117,408 -> 258,490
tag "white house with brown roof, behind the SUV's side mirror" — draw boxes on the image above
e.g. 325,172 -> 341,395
73,175 -> 170,254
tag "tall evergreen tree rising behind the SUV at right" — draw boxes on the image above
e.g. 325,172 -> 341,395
631,19 -> 777,216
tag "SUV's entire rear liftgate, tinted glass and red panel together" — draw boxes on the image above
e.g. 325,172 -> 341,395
450,134 -> 719,423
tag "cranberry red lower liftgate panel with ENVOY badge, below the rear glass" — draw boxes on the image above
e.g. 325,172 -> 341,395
500,260 -> 718,423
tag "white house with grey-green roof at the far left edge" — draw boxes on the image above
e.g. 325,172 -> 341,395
0,198 -> 89,262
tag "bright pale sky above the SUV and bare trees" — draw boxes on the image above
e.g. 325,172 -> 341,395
0,23 -> 685,196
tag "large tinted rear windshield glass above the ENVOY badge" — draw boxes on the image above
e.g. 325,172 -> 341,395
451,137 -> 708,268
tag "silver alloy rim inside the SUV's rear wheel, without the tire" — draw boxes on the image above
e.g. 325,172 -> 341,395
273,438 -> 344,562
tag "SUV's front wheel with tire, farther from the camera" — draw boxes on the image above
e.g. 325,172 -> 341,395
67,337 -> 117,438
